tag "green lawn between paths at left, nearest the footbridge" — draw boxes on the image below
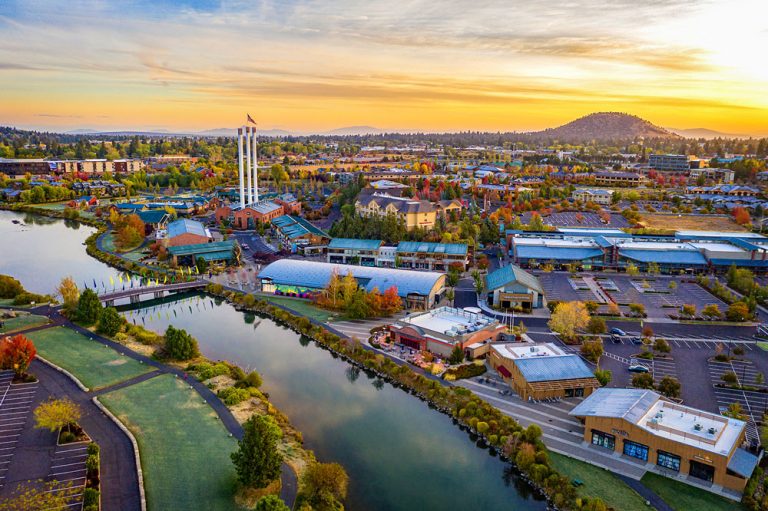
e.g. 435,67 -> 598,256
28,327 -> 152,390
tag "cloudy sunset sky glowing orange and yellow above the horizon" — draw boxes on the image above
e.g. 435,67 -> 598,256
0,0 -> 768,135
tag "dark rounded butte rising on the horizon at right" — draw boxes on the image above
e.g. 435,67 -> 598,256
528,112 -> 679,141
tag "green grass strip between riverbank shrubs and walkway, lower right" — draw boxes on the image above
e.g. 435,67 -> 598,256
549,451 -> 652,511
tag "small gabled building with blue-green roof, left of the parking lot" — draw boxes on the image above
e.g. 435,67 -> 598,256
485,264 -> 547,310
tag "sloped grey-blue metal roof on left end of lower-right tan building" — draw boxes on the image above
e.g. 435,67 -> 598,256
568,387 -> 661,424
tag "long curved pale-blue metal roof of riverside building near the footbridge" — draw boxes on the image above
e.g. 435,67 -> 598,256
259,259 -> 445,297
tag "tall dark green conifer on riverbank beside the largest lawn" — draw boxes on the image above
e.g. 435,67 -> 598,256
230,415 -> 283,488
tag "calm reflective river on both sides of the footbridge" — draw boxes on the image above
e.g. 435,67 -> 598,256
0,212 -> 546,511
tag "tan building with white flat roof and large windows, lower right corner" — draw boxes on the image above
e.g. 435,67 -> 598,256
570,388 -> 758,498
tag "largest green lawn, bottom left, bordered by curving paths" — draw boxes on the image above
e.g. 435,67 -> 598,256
99,374 -> 237,511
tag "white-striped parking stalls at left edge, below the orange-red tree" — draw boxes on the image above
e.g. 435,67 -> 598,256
0,371 -> 37,488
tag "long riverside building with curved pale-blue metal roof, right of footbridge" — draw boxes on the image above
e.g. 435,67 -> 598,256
259,259 -> 445,310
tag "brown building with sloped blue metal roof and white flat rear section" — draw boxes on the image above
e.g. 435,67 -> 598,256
488,343 -> 600,401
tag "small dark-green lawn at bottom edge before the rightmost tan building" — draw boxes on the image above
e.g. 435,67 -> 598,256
640,472 -> 746,511
